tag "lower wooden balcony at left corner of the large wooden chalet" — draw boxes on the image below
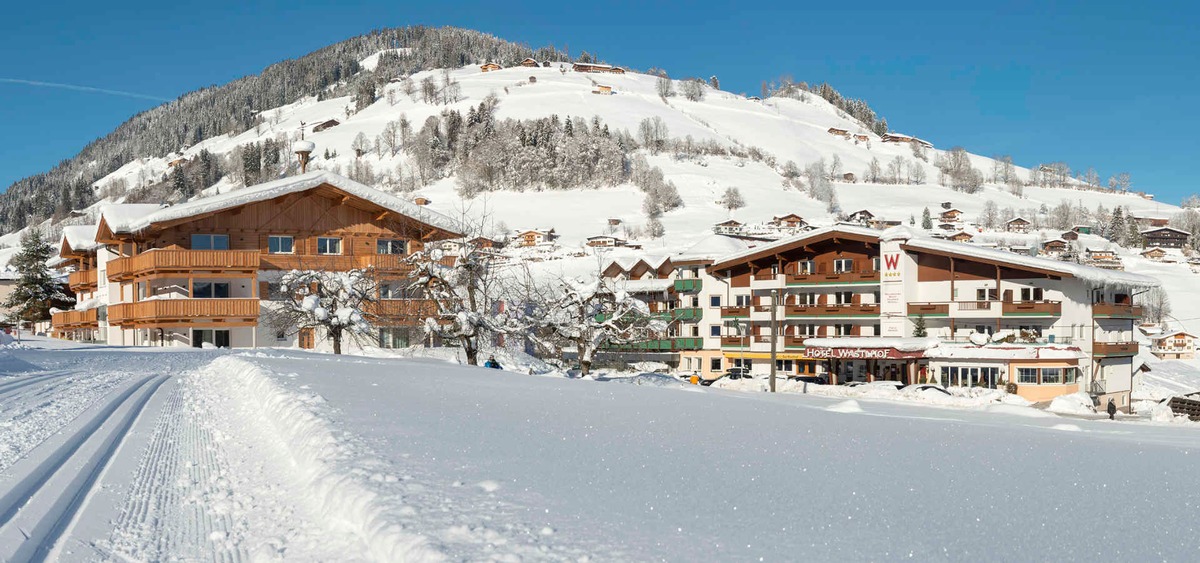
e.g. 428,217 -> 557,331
108,299 -> 258,329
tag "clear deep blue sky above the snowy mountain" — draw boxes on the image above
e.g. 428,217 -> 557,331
0,0 -> 1200,203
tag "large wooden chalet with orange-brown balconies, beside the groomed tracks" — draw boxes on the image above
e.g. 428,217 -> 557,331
53,172 -> 460,348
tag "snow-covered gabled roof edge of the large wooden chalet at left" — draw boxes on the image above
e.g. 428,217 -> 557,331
102,170 -> 462,233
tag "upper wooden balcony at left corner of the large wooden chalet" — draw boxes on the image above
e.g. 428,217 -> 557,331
107,250 -> 259,282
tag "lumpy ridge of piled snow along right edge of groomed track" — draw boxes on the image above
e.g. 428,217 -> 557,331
190,357 -> 442,561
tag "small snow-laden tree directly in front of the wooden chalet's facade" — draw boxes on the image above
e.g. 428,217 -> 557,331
269,269 -> 379,354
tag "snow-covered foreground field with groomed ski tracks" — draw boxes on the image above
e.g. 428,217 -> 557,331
0,339 -> 1200,561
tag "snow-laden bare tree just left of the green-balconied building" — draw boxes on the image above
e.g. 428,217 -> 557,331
529,277 -> 667,377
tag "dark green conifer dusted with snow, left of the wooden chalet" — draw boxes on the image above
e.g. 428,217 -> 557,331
0,228 -> 74,323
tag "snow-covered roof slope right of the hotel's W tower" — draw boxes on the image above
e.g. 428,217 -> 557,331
880,227 -> 1162,288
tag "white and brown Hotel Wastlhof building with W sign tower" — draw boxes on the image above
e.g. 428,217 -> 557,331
702,226 -> 1158,409
